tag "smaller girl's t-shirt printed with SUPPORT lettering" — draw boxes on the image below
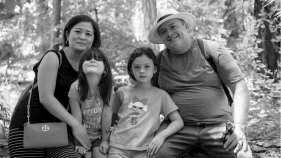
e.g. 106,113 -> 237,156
68,81 -> 103,141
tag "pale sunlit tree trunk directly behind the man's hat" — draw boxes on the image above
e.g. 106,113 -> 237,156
143,0 -> 159,53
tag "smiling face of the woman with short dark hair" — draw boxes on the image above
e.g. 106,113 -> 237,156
67,22 -> 94,51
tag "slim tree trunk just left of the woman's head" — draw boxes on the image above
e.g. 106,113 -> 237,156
51,0 -> 61,50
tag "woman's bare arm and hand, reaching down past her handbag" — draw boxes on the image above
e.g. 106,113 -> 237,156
38,52 -> 91,148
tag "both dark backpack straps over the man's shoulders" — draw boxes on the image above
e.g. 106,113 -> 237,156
153,38 -> 233,106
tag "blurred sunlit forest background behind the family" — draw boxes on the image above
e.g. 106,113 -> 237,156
0,0 -> 281,158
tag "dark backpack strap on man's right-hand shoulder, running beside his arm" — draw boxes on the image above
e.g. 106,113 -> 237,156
197,38 -> 233,106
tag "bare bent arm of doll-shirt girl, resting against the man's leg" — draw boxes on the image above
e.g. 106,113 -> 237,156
147,110 -> 184,156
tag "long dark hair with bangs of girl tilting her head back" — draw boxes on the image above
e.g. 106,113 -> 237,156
78,48 -> 113,106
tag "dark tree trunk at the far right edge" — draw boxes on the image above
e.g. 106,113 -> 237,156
254,0 -> 280,72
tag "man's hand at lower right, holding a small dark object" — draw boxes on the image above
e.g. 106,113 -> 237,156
224,124 -> 248,153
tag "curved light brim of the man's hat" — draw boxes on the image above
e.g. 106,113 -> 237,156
148,12 -> 196,44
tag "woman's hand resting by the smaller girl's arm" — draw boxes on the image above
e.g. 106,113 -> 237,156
72,123 -> 91,150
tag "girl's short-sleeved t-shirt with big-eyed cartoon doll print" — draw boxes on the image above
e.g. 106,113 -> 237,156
110,86 -> 178,151
